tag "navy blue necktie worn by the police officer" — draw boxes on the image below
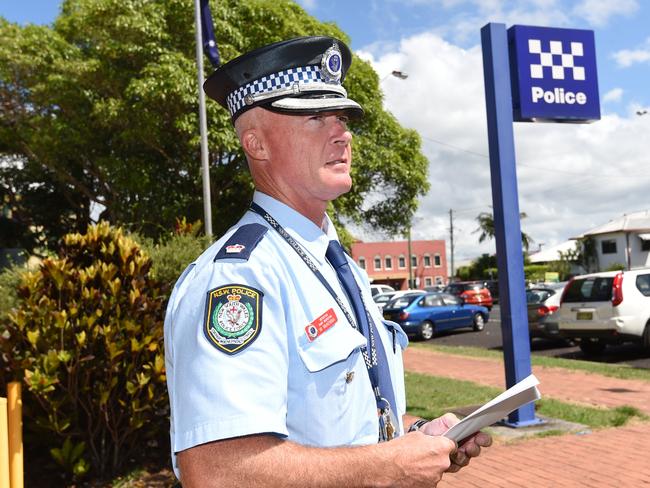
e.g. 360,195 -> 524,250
325,241 -> 397,422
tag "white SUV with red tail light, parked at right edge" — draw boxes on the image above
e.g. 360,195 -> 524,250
559,269 -> 650,354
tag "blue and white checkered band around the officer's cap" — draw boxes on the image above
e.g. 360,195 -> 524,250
226,66 -> 323,115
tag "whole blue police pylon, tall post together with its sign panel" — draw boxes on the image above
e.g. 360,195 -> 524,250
481,23 -> 600,427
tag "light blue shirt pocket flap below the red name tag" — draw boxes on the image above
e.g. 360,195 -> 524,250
298,323 -> 366,373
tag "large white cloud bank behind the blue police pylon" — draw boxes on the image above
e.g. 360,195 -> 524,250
356,33 -> 650,260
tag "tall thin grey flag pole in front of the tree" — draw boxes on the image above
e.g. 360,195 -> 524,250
194,0 -> 212,236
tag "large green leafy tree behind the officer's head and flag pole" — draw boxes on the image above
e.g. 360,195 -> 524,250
0,0 -> 428,252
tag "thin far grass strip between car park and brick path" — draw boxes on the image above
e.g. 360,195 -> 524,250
409,343 -> 650,381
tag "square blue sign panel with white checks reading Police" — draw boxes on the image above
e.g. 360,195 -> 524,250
508,25 -> 600,122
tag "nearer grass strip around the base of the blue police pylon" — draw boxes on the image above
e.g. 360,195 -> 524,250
405,372 -> 648,428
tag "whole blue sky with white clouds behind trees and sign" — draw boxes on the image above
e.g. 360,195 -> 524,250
0,0 -> 650,262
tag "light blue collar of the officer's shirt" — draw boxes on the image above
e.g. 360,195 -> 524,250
253,190 -> 339,265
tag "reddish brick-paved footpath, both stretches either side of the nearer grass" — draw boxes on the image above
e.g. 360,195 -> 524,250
404,347 -> 650,488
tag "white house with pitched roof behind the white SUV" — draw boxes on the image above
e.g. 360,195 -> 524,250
574,210 -> 650,270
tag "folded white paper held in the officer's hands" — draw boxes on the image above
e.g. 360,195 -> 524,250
443,374 -> 542,442
